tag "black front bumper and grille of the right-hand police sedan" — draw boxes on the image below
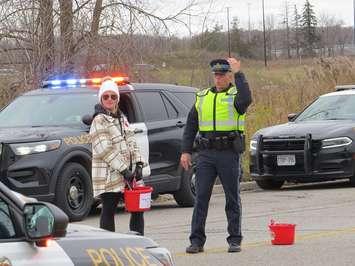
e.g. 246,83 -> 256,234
249,135 -> 354,183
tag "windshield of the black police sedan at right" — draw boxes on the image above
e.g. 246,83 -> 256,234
295,94 -> 355,122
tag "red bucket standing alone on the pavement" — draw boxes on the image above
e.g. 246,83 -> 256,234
269,220 -> 296,245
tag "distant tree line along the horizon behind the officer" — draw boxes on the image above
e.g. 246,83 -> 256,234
186,0 -> 353,59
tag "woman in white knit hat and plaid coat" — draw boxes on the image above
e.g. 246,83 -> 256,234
90,79 -> 145,235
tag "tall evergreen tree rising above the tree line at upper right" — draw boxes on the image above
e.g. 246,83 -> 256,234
301,0 -> 319,56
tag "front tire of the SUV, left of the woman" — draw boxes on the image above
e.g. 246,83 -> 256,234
56,163 -> 93,222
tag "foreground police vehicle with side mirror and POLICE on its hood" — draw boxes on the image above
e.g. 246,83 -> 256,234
0,182 -> 173,266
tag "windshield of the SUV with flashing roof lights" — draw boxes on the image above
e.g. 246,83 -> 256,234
0,93 -> 97,127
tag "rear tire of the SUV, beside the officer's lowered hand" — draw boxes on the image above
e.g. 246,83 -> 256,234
173,159 -> 196,207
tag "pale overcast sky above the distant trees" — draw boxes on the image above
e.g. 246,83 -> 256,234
157,0 -> 353,36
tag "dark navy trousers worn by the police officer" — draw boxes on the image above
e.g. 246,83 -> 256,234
190,149 -> 242,246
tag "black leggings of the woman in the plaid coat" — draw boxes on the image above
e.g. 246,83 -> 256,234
100,192 -> 144,235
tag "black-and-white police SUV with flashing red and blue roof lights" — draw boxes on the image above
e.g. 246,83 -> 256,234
0,76 -> 195,221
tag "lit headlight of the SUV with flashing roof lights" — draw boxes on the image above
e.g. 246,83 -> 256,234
10,140 -> 61,155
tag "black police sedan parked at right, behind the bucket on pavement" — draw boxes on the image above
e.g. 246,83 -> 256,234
250,86 -> 355,189
